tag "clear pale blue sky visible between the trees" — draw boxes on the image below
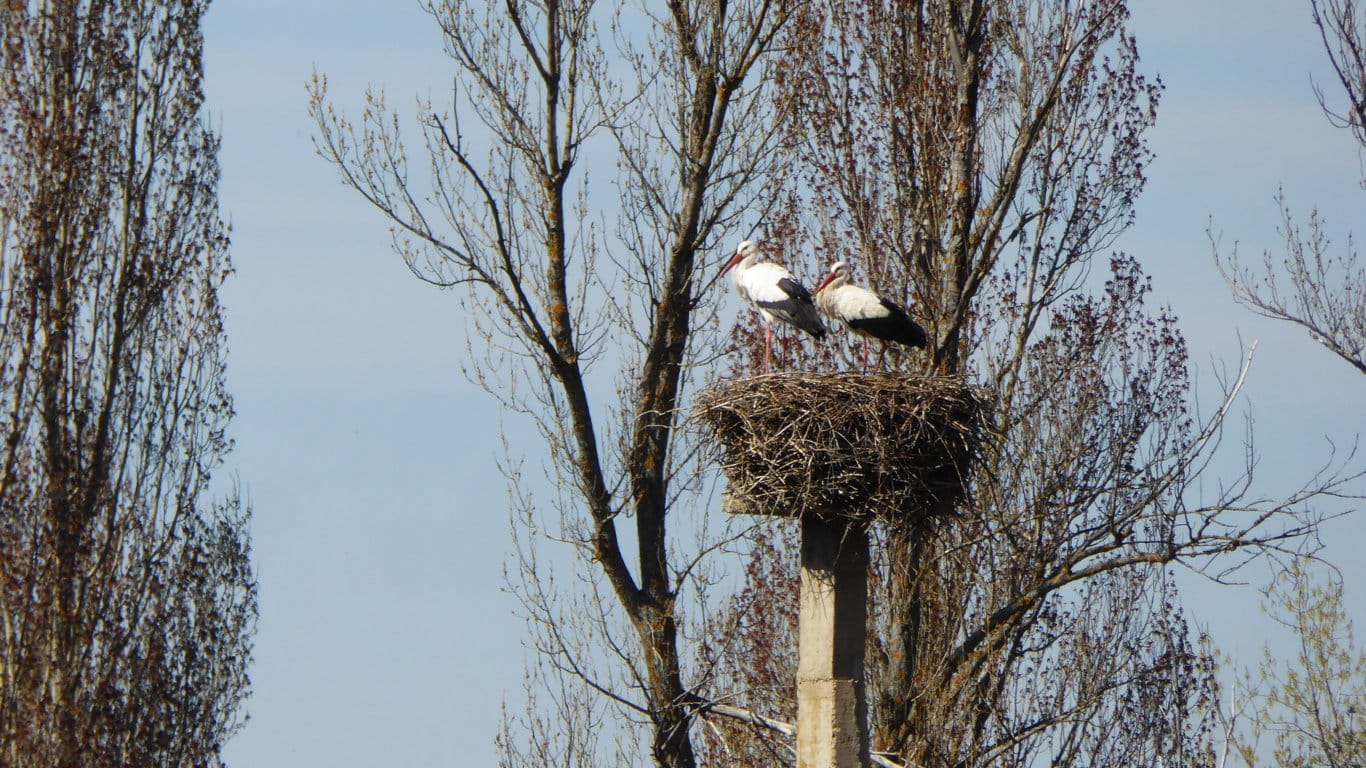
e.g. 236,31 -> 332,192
206,0 -> 1366,768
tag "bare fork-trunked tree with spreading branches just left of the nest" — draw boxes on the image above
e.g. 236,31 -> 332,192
311,0 -> 792,767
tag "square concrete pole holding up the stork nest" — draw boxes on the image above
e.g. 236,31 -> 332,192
796,515 -> 869,768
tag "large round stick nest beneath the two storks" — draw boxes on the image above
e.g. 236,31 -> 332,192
697,373 -> 989,521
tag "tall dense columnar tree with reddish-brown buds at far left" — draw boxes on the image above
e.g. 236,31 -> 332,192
0,0 -> 255,768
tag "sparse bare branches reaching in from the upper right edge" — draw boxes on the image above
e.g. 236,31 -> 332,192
1214,0 -> 1366,373
